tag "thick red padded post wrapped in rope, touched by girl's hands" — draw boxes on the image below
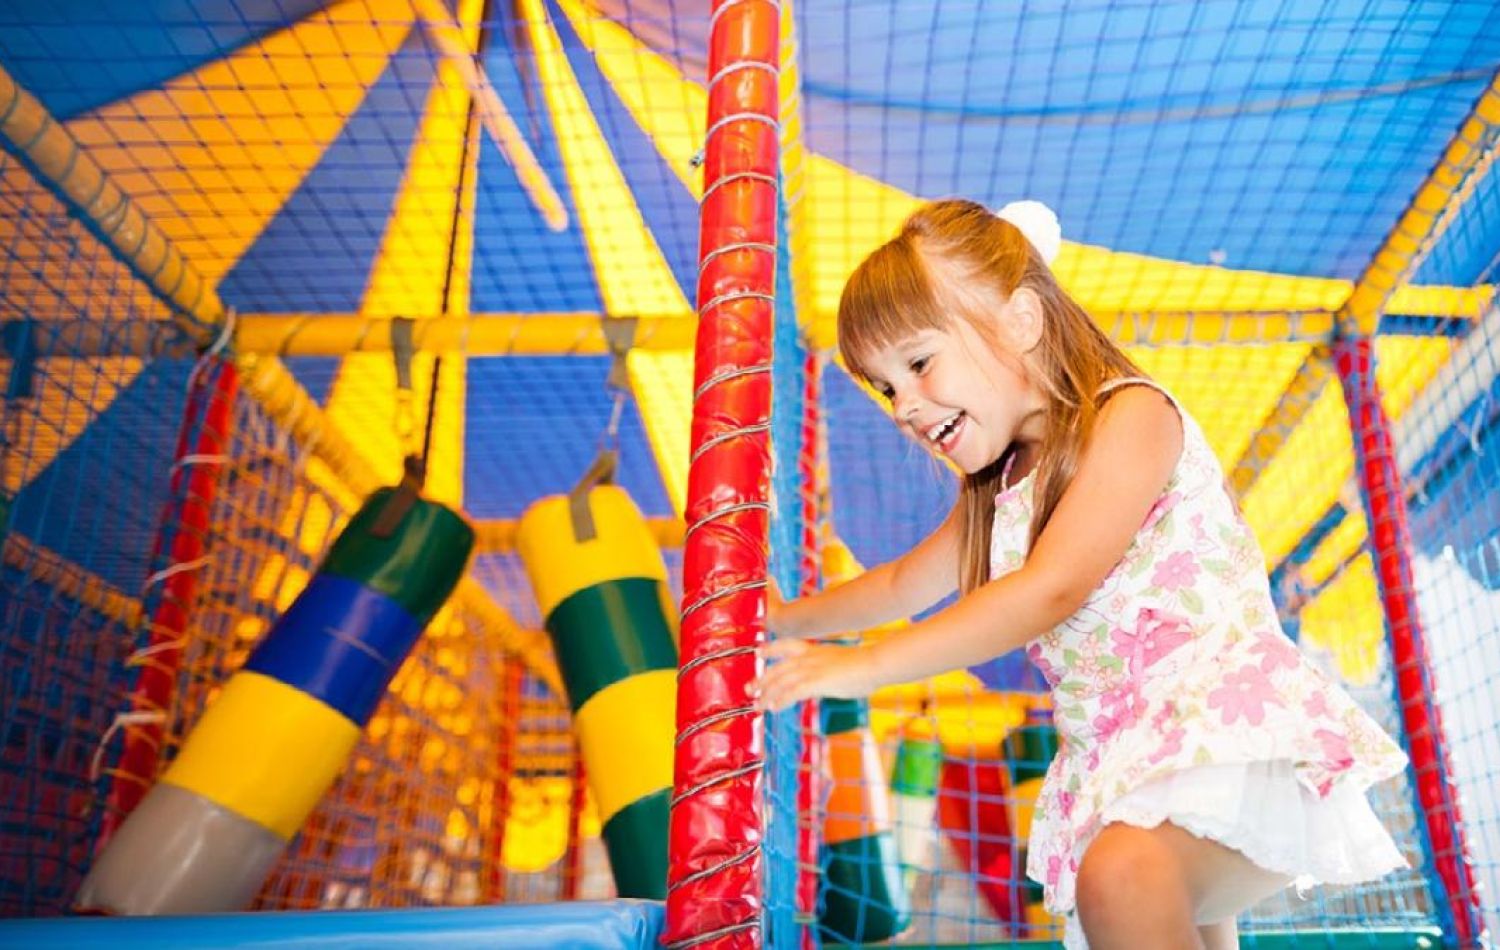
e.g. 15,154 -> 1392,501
663,0 -> 780,948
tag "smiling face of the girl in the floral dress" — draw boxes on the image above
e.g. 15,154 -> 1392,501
864,307 -> 1046,474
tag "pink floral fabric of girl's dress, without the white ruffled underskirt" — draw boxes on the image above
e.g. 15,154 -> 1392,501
990,378 -> 1406,914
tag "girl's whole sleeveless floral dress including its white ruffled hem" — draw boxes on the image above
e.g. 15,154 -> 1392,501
990,380 -> 1406,945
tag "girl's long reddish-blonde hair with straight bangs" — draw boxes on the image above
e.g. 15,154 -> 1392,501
839,198 -> 1145,593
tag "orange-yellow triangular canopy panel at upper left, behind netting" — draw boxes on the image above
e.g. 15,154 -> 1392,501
68,0 -> 411,284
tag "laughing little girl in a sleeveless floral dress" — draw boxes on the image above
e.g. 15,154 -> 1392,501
759,200 -> 1406,950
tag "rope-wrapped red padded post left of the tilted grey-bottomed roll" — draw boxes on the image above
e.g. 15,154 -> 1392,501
95,359 -> 239,852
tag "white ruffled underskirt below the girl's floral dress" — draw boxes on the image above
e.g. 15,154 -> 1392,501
1064,761 -> 1407,950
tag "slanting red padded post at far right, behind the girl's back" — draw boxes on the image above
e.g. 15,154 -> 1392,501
1334,336 -> 1485,947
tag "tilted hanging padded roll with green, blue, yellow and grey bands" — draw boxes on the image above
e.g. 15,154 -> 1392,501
77,485 -> 474,914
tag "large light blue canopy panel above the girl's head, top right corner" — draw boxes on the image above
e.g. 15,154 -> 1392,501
798,0 -> 1500,278
